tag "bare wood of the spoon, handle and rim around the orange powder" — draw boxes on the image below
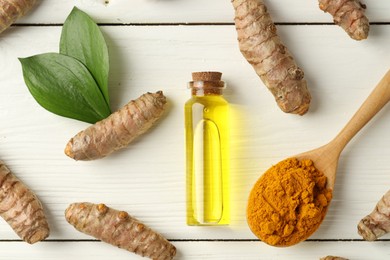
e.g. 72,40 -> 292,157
294,70 -> 390,189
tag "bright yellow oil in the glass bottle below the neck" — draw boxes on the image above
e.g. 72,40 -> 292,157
185,95 -> 230,225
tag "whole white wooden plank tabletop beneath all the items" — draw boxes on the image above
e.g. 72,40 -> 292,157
0,0 -> 390,260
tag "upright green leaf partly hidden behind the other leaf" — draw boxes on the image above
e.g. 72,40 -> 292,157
60,7 -> 110,106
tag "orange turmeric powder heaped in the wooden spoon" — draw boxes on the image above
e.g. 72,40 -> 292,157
247,158 -> 332,246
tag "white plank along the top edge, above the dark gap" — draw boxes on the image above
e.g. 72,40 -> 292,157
10,0 -> 390,24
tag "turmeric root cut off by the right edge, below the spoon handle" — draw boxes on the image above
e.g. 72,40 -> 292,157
358,190 -> 390,241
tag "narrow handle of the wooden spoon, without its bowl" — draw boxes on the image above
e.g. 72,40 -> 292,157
332,70 -> 390,152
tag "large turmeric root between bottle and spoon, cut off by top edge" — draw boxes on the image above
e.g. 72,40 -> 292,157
231,0 -> 311,115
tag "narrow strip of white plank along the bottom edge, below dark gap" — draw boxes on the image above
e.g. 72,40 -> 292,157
0,242 -> 390,260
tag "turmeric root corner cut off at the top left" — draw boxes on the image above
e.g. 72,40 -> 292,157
0,0 -> 36,33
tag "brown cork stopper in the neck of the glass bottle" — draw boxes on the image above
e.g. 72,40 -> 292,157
189,71 -> 225,96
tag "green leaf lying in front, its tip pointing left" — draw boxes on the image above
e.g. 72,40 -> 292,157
19,53 -> 111,123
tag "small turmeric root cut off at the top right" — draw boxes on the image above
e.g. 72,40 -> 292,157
319,0 -> 370,40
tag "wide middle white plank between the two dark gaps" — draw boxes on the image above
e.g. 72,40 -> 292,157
0,25 -> 390,242
